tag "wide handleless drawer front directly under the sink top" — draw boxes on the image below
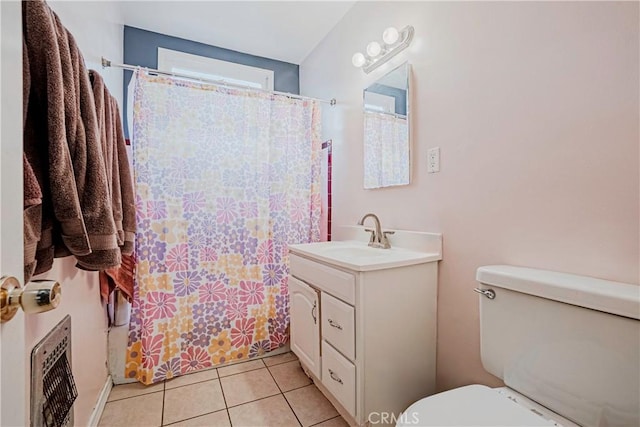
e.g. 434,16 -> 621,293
289,253 -> 356,305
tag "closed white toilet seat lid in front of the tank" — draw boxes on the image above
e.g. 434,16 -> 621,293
396,384 -> 577,427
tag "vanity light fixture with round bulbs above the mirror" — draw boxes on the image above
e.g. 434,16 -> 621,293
351,25 -> 414,74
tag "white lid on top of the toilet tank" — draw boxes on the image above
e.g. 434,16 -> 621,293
476,265 -> 640,319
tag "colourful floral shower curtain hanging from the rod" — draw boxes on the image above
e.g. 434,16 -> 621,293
126,72 -> 321,384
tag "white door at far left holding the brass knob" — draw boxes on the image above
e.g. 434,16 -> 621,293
0,1 -> 29,426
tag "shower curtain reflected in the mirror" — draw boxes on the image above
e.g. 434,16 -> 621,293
364,111 -> 410,188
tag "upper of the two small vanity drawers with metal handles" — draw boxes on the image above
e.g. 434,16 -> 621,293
320,292 -> 356,360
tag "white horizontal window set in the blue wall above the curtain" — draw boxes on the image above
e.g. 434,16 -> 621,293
158,47 -> 273,90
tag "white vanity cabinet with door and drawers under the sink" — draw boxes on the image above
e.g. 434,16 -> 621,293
289,237 -> 441,426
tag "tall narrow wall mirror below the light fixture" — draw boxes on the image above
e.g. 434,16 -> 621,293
364,62 -> 411,189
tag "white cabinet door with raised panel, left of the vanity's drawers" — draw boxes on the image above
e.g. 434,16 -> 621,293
289,276 -> 320,378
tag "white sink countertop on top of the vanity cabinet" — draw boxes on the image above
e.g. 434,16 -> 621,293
289,241 -> 442,271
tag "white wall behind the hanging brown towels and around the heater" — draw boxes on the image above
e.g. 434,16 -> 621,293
25,1 -> 123,426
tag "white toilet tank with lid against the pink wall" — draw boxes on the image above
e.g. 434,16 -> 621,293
476,265 -> 640,427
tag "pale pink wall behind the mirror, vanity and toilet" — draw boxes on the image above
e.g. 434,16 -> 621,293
300,2 -> 640,390
